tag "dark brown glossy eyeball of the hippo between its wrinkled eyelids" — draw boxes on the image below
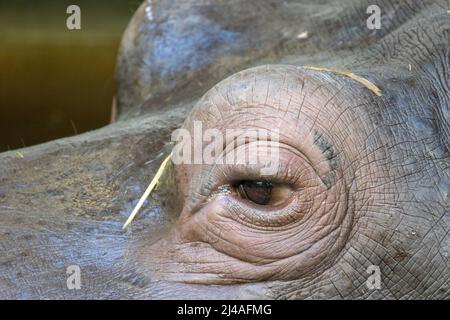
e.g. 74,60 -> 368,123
234,180 -> 291,206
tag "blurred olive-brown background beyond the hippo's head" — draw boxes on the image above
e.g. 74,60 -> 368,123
0,0 -> 140,152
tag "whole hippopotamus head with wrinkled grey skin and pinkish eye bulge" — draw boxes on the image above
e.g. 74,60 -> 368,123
0,0 -> 450,299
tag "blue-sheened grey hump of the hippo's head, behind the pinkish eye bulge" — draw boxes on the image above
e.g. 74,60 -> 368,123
117,0 -> 310,119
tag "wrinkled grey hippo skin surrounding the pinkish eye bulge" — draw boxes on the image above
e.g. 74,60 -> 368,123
0,0 -> 450,299
